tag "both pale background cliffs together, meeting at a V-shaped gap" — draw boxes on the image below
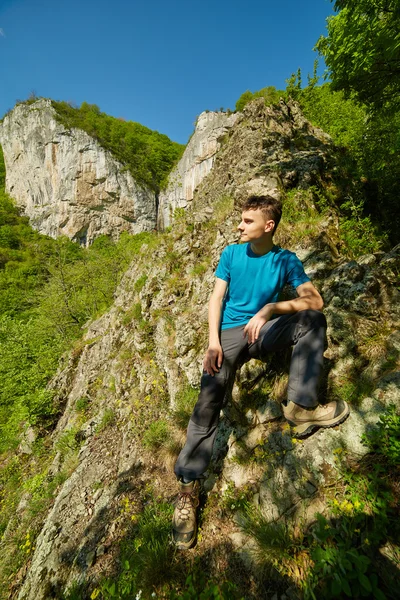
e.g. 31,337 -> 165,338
0,99 -> 240,245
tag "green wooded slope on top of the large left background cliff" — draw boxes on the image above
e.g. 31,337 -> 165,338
52,101 -> 184,193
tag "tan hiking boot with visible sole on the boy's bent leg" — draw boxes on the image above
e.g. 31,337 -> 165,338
283,400 -> 350,438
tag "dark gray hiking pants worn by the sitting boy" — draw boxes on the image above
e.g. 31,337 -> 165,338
175,310 -> 326,479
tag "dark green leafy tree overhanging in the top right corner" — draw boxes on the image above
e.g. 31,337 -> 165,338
316,0 -> 400,110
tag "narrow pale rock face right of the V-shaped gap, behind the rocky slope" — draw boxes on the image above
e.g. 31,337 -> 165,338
158,112 -> 239,229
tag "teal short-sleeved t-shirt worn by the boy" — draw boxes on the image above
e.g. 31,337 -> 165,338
215,243 -> 310,329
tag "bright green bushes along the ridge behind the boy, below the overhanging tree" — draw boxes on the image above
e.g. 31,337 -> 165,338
236,71 -> 400,246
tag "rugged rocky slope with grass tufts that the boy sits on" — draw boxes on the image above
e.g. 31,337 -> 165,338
4,100 -> 400,600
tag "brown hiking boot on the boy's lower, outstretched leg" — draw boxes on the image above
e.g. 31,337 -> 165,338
172,479 -> 200,550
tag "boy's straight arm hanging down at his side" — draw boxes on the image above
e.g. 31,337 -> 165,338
203,277 -> 228,375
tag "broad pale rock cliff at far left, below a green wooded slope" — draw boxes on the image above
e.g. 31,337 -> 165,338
0,99 -> 156,245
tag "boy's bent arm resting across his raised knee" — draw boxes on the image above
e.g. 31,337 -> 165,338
244,281 -> 324,343
